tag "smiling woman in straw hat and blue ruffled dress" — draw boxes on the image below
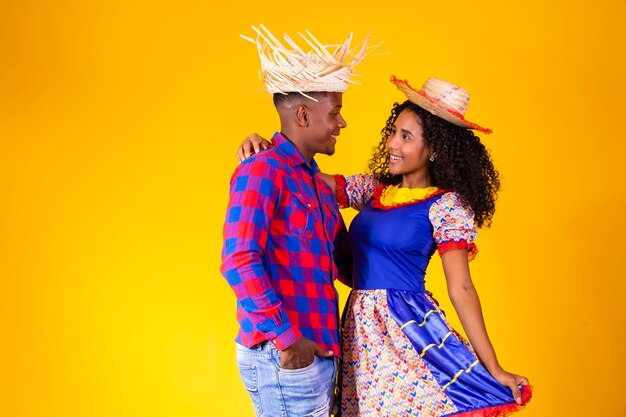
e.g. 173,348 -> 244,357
236,77 -> 531,417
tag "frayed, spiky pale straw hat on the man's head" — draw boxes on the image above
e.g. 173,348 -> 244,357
240,25 -> 369,98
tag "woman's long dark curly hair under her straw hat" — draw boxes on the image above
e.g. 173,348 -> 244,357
369,100 -> 500,227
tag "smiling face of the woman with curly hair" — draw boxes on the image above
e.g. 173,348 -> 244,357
387,109 -> 430,187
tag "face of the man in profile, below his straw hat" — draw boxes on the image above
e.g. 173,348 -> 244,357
303,93 -> 346,155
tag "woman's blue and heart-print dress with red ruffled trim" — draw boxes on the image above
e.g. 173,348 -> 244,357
342,176 -> 530,417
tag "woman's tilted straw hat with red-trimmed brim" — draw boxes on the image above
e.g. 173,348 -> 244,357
391,75 -> 492,134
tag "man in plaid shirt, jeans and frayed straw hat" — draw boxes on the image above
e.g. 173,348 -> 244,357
221,26 -> 367,417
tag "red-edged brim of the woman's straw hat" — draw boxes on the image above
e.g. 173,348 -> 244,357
391,75 -> 493,134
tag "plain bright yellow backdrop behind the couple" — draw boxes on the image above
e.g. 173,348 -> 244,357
0,0 -> 626,417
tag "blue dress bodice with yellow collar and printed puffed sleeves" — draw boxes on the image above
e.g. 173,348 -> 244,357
346,180 -> 477,292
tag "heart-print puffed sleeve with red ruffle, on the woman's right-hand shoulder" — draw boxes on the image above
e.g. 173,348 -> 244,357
429,193 -> 478,261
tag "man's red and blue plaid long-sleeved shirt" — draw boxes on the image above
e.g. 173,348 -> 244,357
221,134 -> 351,356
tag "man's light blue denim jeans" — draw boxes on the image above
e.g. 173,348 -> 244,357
237,342 -> 337,417
